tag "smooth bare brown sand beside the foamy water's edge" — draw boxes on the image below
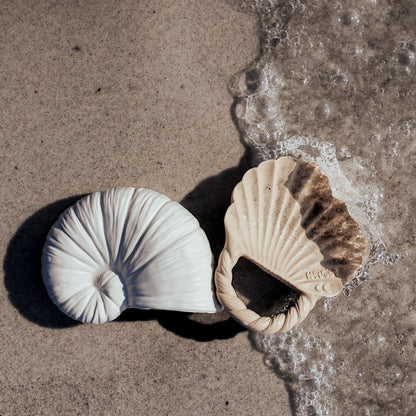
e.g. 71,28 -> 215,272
0,0 -> 289,416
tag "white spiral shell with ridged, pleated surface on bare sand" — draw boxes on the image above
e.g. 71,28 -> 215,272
42,188 -> 222,323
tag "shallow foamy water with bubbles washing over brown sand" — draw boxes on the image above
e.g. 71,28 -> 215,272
229,0 -> 416,415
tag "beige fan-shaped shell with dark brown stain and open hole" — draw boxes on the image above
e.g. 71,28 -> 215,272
215,157 -> 367,334
